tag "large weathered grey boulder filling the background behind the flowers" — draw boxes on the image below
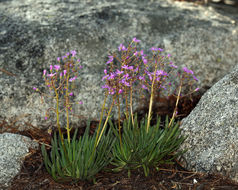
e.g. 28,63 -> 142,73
0,0 -> 238,126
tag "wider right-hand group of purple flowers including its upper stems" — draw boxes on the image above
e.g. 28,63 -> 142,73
102,38 -> 198,132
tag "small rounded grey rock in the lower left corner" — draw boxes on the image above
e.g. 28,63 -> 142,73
0,133 -> 38,189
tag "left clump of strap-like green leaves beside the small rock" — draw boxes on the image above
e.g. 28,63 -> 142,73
41,122 -> 114,181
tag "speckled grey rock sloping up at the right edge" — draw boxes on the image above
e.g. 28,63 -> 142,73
181,65 -> 238,181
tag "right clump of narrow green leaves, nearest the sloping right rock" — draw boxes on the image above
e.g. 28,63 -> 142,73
110,116 -> 186,176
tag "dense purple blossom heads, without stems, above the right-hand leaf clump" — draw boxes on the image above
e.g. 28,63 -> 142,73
102,38 -> 198,101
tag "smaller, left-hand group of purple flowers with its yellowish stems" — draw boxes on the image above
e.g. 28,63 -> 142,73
33,50 -> 83,141
